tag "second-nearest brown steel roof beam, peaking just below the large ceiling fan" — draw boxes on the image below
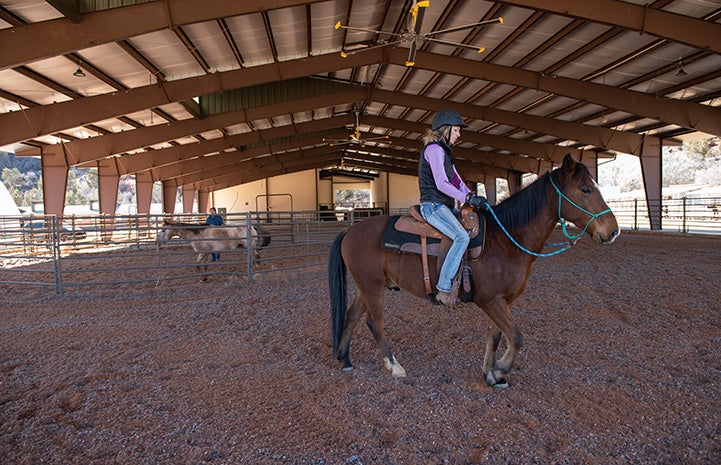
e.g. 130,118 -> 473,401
5,44 -> 721,152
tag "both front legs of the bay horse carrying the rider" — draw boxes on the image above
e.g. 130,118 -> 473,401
483,299 -> 523,387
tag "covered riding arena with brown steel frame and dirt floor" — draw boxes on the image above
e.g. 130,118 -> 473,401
0,0 -> 721,465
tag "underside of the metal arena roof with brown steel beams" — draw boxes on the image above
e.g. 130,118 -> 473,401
0,0 -> 721,191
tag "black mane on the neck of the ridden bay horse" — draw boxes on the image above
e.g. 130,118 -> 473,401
487,171 -> 551,231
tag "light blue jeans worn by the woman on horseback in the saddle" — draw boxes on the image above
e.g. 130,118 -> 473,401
421,202 -> 471,292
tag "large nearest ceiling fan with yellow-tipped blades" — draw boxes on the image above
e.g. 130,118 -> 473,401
335,1 -> 503,66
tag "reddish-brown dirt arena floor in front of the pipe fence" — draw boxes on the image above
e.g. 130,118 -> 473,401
0,233 -> 721,465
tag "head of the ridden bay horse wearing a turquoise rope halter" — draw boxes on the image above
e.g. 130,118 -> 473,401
549,154 -> 620,244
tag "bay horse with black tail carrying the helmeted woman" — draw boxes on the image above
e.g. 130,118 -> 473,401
328,154 -> 619,387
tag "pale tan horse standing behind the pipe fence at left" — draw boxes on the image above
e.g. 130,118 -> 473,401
156,220 -> 270,281
